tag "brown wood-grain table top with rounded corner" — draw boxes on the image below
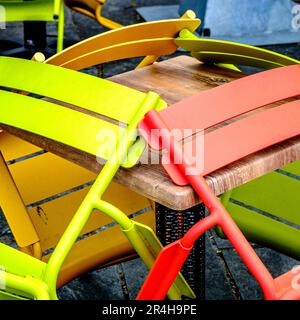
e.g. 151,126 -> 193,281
1,56 -> 300,210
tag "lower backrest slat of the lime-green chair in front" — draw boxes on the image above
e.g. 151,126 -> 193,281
0,90 -> 125,159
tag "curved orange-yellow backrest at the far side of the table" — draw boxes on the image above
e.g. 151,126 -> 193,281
46,12 -> 200,70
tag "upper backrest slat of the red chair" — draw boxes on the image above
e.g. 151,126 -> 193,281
140,65 -> 300,149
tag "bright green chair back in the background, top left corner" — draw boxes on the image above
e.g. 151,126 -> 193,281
0,0 -> 64,52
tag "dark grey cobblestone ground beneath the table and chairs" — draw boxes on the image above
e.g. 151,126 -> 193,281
0,0 -> 300,300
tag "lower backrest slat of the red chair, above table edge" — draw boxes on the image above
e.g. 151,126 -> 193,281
185,100 -> 300,175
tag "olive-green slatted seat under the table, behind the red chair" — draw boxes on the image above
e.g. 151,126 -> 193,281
217,161 -> 300,260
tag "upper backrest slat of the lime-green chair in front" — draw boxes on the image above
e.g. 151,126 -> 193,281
0,57 -> 166,123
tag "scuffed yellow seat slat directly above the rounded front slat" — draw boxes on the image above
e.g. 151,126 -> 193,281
29,183 -> 154,251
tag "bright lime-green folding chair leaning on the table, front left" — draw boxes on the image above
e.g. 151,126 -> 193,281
0,57 -> 194,299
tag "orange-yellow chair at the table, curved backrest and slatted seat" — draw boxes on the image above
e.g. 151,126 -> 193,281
0,18 -> 200,286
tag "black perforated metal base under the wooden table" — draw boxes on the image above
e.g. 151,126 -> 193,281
155,203 -> 205,300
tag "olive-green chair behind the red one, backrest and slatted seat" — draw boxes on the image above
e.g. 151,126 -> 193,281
175,30 -> 300,260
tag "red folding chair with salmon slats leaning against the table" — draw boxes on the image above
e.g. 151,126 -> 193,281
137,65 -> 300,300
